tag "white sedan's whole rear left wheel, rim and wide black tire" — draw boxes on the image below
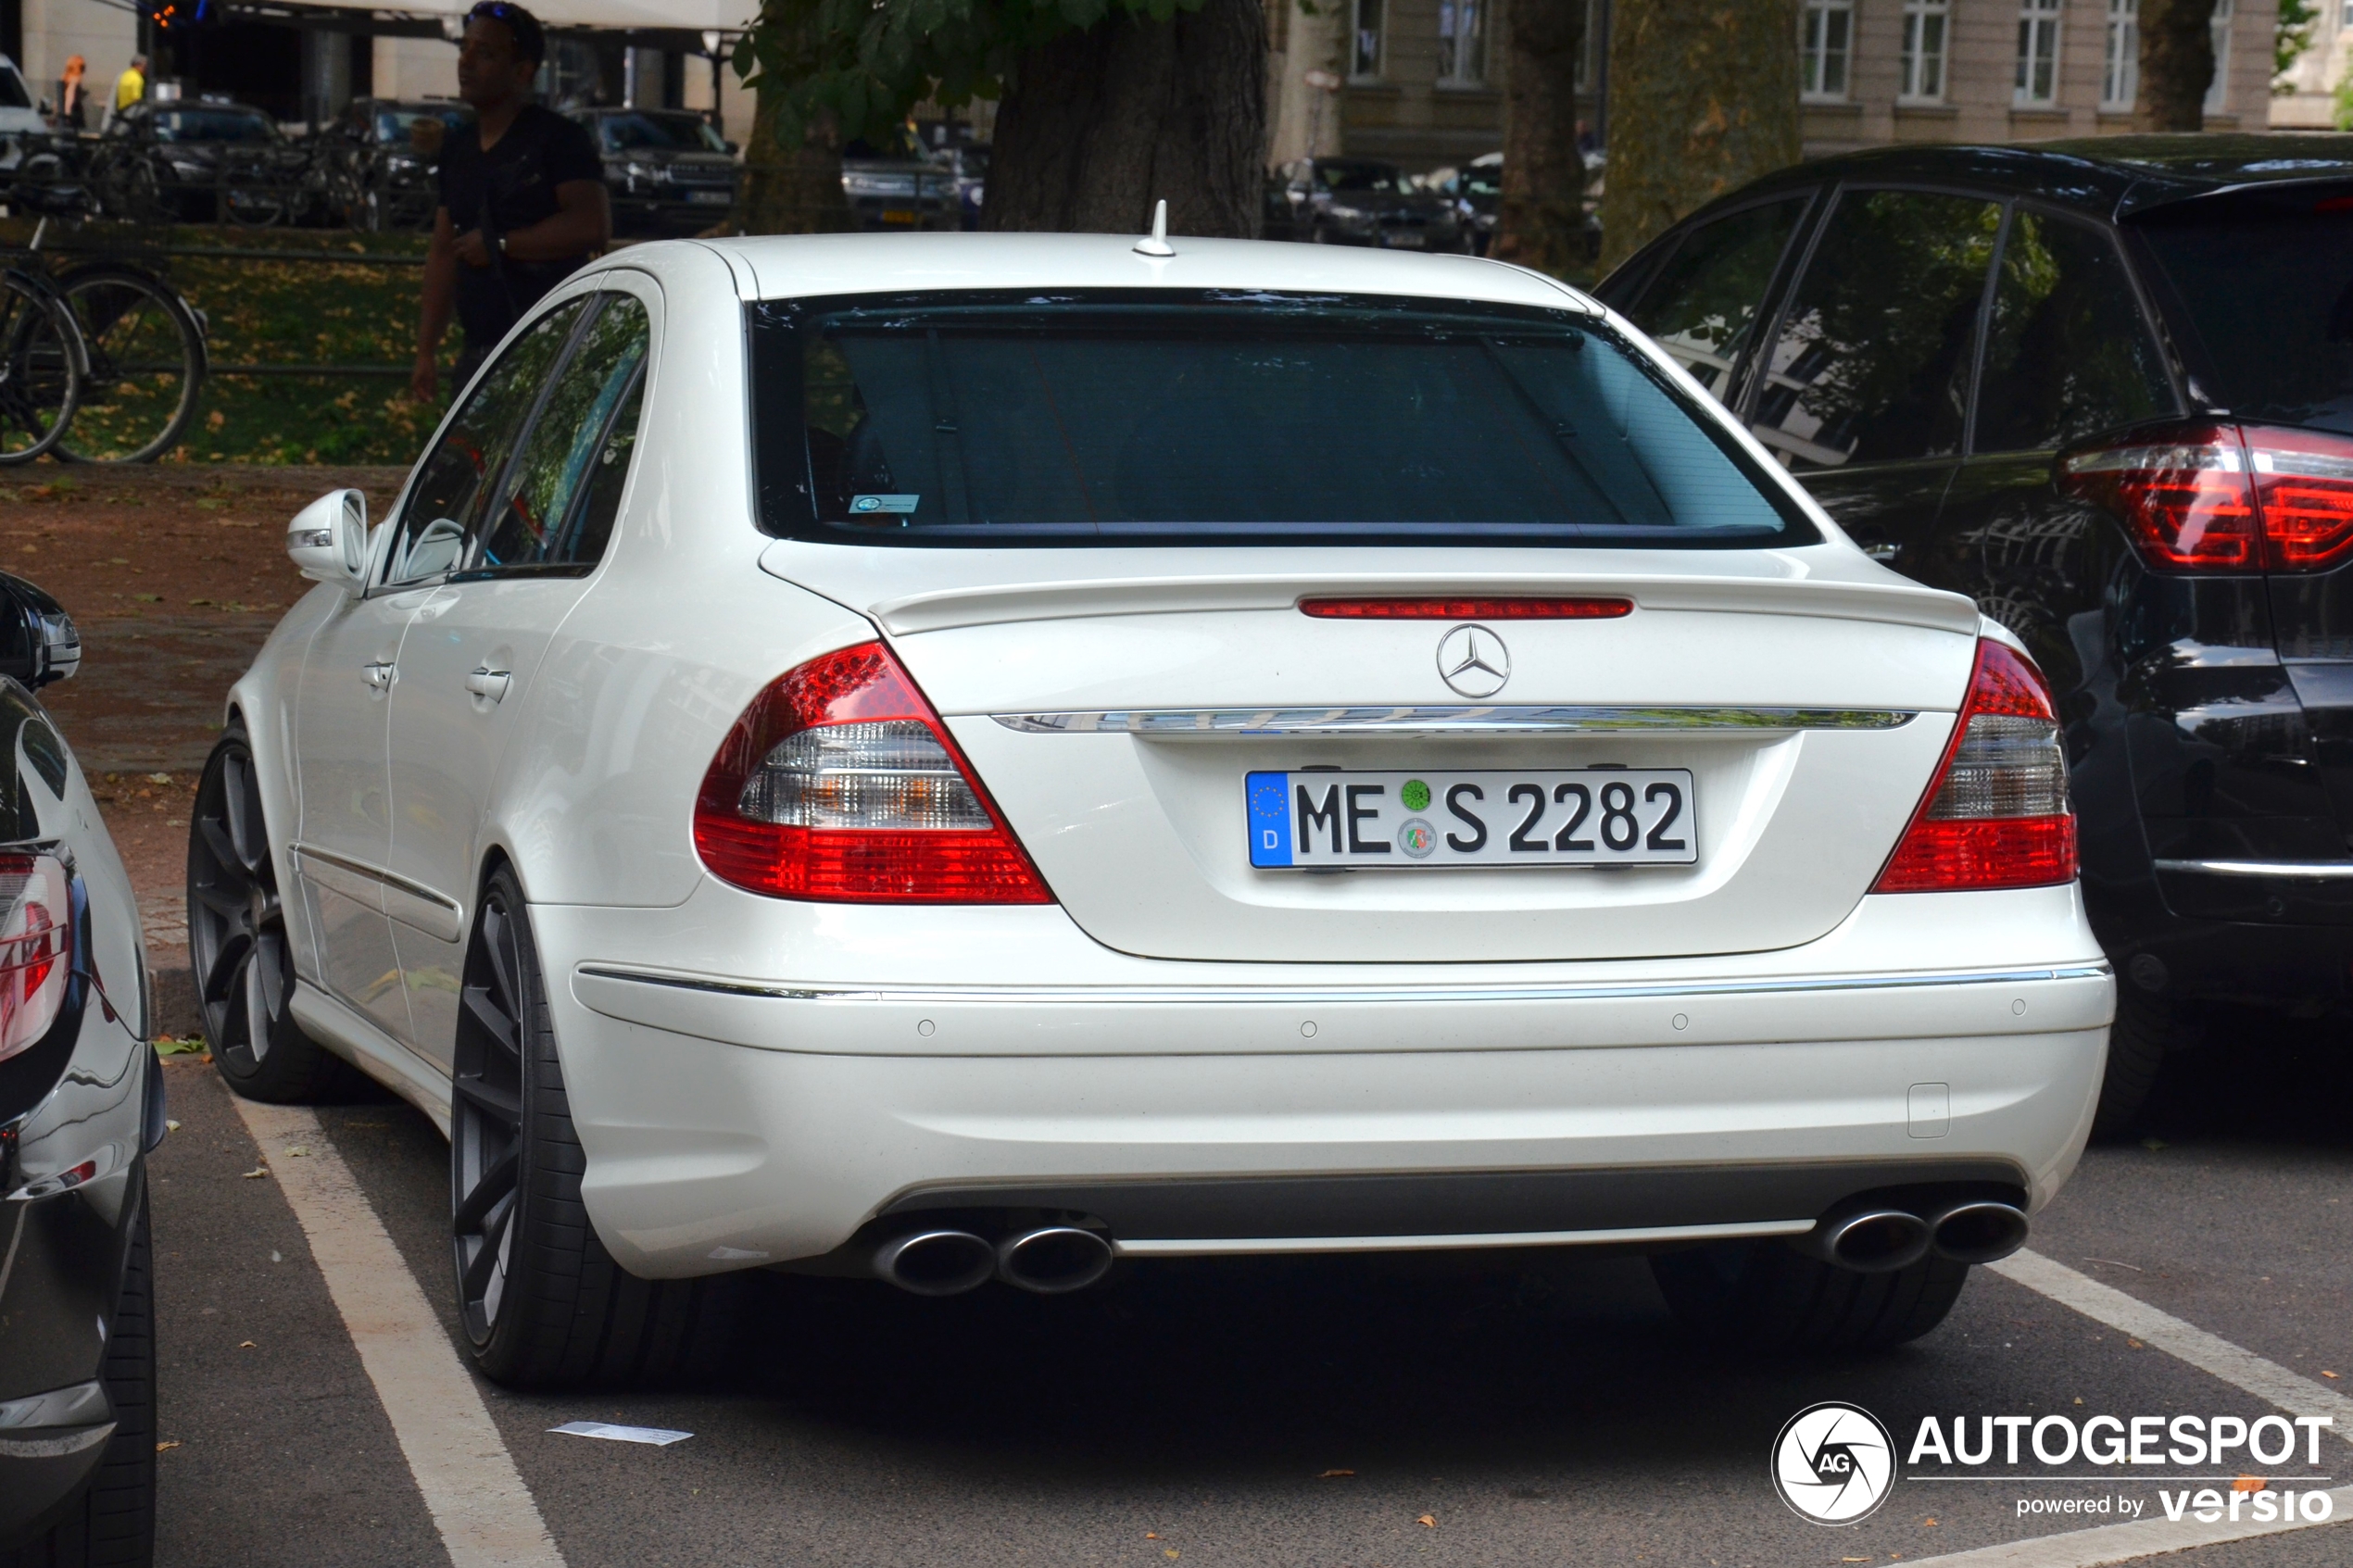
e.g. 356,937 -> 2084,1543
449,868 -> 749,1389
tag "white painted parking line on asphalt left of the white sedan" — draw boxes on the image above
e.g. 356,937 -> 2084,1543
235,1100 -> 565,1568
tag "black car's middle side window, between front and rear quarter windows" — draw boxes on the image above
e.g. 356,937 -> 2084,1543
1753,191 -> 2003,470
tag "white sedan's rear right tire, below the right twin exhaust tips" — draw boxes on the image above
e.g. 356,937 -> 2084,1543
1650,1241 -> 1969,1354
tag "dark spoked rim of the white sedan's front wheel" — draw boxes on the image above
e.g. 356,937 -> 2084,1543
188,746 -> 295,1074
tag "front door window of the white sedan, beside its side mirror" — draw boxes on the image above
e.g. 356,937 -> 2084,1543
384,298 -> 588,583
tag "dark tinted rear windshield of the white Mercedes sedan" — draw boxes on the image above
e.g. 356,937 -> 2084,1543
750,292 -> 1818,547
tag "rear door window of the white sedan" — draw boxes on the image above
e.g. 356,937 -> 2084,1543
466,294 -> 652,571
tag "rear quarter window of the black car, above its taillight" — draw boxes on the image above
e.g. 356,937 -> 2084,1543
1974,209 -> 2174,451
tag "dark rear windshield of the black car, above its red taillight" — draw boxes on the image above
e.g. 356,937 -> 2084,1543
2134,186 -> 2353,430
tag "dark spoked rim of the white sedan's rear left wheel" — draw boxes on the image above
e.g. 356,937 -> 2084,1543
449,884 -> 524,1345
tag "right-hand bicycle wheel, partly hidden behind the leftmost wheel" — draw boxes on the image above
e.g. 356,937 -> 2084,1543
57,261 -> 205,463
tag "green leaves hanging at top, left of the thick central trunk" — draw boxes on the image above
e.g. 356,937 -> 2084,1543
734,0 -> 1202,145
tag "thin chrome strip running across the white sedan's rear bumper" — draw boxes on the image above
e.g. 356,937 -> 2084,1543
576,960 -> 2110,1006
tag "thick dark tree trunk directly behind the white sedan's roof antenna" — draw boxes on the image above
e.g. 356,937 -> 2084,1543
981,0 -> 1266,240
